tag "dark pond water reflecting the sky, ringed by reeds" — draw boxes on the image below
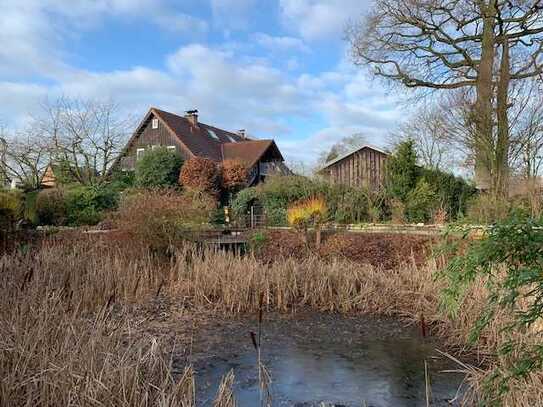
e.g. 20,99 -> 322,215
185,314 -> 463,407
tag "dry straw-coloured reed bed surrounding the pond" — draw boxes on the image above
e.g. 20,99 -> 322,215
0,239 -> 543,407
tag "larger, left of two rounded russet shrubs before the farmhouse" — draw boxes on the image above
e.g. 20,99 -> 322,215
179,157 -> 220,195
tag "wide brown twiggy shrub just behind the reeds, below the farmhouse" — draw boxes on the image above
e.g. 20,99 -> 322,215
112,190 -> 215,251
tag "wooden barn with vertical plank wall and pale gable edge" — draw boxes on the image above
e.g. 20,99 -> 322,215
320,145 -> 389,190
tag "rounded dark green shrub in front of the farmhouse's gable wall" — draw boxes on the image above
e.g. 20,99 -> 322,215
136,147 -> 183,188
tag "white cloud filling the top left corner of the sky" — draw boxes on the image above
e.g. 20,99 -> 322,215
0,0 -> 208,79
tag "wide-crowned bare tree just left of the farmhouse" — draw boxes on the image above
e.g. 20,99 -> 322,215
37,98 -> 133,185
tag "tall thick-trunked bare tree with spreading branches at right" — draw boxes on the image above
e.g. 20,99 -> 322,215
347,0 -> 543,198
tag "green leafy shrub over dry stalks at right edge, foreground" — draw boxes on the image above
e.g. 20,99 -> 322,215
441,214 -> 543,405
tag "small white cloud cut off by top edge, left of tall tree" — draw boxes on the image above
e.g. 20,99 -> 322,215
280,0 -> 370,40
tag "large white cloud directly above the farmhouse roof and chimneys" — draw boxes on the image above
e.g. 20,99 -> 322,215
167,44 -> 304,128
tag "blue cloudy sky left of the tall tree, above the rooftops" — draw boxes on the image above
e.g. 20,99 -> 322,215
0,0 -> 403,163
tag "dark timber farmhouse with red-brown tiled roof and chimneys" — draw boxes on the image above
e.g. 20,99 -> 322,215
113,107 -> 290,185
